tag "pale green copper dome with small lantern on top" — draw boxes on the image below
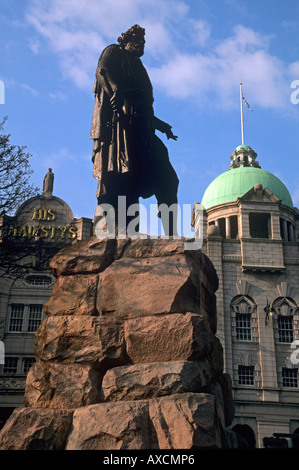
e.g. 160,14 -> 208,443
201,145 -> 293,209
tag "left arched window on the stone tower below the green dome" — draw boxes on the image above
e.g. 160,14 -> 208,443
231,295 -> 256,341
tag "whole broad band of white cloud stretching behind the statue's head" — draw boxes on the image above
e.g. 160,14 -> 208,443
27,0 -> 299,109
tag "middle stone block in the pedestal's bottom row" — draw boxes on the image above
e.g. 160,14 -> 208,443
66,401 -> 149,450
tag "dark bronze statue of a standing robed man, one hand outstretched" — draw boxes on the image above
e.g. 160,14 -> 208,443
90,25 -> 179,235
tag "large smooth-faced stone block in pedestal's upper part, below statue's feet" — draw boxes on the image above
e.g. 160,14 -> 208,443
97,255 -> 204,318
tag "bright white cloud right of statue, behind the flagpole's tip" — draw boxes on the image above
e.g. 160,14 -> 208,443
150,25 -> 295,109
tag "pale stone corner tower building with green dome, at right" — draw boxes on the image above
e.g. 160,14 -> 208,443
201,145 -> 299,447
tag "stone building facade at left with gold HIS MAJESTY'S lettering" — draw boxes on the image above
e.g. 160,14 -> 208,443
0,171 -> 92,427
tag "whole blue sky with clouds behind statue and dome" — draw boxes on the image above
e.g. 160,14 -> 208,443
0,0 -> 299,222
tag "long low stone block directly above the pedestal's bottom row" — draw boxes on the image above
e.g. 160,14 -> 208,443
101,359 -> 212,401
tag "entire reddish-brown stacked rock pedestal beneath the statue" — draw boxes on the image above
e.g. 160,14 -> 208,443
0,237 -> 234,450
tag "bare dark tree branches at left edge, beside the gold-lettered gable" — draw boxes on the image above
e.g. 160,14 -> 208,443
0,117 -> 65,278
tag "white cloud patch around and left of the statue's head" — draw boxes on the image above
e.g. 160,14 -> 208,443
26,0 -> 188,88
